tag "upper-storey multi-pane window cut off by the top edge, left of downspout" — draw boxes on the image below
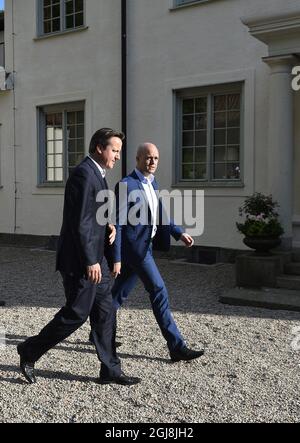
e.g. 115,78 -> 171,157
39,0 -> 85,35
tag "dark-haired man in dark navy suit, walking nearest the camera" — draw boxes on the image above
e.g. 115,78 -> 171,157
18,128 -> 140,385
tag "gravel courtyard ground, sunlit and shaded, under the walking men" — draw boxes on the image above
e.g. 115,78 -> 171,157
0,247 -> 300,423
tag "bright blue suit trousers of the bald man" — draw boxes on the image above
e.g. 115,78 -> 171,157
112,246 -> 185,351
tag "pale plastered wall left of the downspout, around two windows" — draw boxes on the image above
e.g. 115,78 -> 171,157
0,0 -> 121,235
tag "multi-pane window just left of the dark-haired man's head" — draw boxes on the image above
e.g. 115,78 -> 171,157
39,104 -> 85,185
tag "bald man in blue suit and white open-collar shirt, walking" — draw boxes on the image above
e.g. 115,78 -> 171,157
112,143 -> 204,361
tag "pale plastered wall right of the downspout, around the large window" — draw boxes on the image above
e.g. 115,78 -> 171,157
128,0 -> 299,248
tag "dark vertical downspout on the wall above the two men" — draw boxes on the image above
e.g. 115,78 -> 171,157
121,0 -> 127,177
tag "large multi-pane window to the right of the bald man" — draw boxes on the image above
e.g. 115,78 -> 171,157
177,87 -> 242,182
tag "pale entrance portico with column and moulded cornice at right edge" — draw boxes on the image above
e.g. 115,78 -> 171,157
242,10 -> 300,249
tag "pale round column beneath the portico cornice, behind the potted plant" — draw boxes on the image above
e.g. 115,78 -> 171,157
263,55 -> 299,249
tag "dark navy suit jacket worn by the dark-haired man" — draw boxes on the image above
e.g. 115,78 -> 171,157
56,157 -> 107,276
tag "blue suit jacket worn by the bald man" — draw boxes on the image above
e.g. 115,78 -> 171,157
113,171 -> 184,264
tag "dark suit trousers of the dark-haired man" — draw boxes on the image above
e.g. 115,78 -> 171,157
21,258 -> 121,376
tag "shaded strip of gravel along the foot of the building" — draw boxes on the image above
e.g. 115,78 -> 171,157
0,247 -> 300,322
